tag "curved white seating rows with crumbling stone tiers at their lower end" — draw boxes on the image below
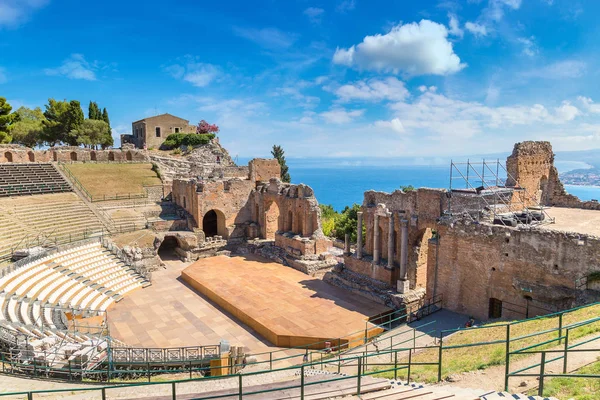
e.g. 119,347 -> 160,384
0,242 -> 149,366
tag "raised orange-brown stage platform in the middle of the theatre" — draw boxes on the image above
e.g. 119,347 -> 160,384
181,255 -> 391,349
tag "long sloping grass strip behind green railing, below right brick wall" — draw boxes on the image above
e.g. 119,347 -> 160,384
372,305 -> 600,383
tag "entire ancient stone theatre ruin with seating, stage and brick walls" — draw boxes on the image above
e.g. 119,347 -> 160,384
0,138 -> 600,396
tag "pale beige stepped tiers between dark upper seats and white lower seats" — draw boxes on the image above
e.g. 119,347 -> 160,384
0,193 -> 105,261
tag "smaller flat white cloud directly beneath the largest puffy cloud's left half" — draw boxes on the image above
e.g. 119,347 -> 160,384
326,77 -> 409,102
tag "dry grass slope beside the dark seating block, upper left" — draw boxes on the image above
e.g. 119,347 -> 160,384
67,163 -> 161,197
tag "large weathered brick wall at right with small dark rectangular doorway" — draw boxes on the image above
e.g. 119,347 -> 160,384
427,222 -> 600,319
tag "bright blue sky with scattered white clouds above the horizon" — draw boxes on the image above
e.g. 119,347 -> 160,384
0,0 -> 600,157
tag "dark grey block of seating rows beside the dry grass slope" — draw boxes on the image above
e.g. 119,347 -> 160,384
0,163 -> 72,197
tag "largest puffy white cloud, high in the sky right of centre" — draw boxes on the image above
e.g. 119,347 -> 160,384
333,20 -> 466,75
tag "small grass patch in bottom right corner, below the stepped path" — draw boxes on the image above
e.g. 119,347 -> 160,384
531,361 -> 600,400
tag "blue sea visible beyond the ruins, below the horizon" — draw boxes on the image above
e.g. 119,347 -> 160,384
290,165 -> 600,211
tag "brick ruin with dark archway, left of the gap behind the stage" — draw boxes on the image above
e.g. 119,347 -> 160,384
172,159 -> 330,256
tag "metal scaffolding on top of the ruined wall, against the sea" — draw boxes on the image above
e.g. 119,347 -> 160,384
447,159 -> 554,226
